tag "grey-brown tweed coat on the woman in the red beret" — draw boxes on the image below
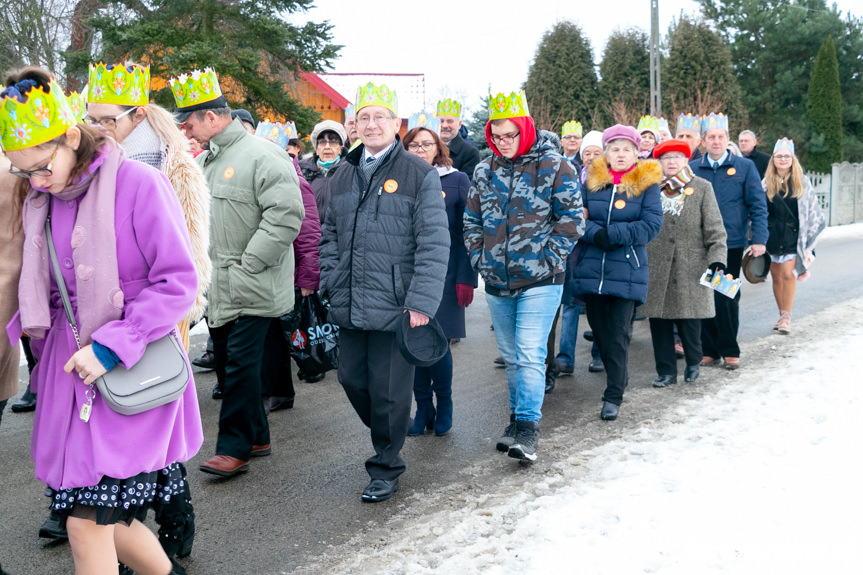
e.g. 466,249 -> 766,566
641,177 -> 728,319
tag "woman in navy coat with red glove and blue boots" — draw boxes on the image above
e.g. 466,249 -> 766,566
404,124 -> 477,435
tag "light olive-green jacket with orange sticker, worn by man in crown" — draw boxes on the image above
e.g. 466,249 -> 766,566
197,120 -> 305,327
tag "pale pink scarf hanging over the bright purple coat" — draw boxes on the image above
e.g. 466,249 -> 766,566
18,141 -> 124,346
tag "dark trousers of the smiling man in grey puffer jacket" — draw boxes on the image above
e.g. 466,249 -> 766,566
339,328 -> 414,480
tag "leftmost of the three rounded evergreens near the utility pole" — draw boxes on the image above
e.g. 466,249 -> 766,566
524,21 -> 597,133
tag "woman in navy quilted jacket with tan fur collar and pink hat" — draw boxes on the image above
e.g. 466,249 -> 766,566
575,124 -> 662,420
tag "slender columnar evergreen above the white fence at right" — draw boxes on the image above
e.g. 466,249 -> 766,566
805,36 -> 842,173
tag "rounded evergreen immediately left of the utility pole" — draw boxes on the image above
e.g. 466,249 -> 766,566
599,28 -> 650,126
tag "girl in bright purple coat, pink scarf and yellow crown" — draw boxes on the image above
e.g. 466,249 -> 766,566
0,68 -> 203,575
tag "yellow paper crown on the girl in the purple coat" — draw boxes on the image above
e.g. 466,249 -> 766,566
0,80 -> 76,152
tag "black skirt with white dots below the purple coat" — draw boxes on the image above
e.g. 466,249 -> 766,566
51,463 -> 186,525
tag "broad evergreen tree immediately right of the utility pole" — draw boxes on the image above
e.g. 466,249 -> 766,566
662,16 -> 747,132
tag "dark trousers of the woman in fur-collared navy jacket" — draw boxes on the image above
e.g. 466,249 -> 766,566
583,294 -> 635,405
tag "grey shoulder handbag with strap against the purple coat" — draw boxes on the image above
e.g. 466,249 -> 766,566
45,207 -> 191,422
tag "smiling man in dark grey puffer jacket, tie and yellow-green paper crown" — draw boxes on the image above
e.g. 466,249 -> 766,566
319,83 -> 450,502
